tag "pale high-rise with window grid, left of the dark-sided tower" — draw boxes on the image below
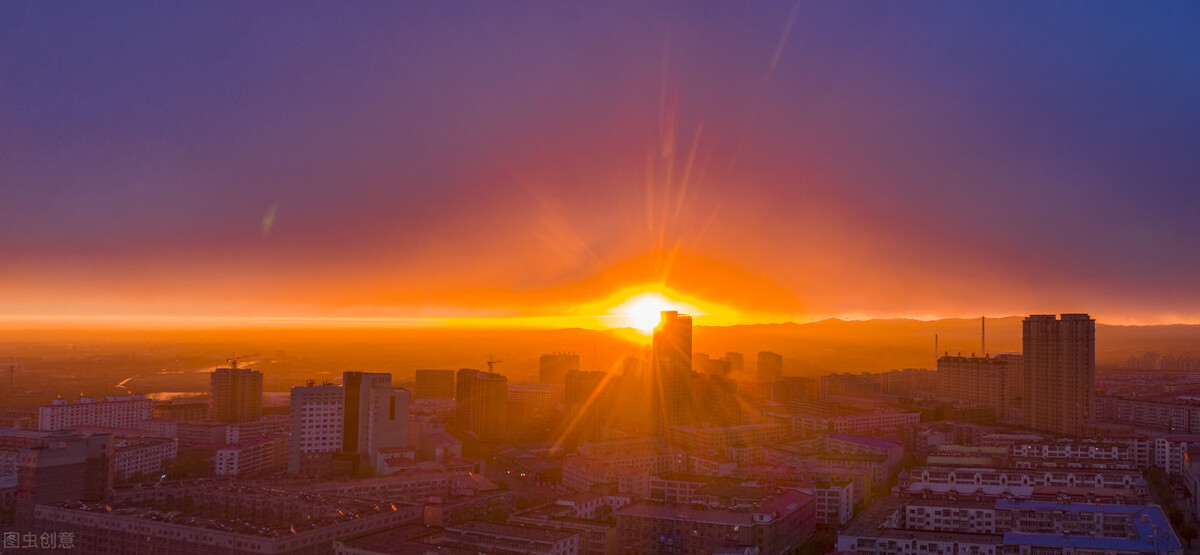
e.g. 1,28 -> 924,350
288,382 -> 346,475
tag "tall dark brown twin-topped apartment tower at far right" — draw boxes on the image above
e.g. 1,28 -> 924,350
1022,314 -> 1096,436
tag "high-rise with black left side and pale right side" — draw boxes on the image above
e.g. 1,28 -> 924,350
340,372 -> 409,473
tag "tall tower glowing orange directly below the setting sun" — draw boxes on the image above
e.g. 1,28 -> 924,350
650,310 -> 694,432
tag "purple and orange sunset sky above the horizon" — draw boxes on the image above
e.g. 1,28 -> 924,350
7,2 -> 1200,328
